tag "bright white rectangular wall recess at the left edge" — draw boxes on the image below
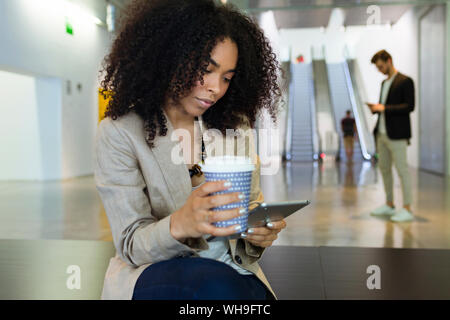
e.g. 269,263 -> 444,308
0,71 -> 61,180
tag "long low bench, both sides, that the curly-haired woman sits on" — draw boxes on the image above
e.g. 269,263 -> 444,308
0,240 -> 450,300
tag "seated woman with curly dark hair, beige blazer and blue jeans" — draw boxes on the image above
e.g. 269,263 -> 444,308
95,0 -> 286,299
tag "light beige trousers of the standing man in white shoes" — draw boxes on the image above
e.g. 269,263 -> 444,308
377,133 -> 412,206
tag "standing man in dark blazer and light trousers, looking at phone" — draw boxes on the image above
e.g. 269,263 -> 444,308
367,50 -> 414,222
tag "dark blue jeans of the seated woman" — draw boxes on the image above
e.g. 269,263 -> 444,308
133,257 -> 274,300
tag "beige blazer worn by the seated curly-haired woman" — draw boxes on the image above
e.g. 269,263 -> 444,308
94,112 -> 275,299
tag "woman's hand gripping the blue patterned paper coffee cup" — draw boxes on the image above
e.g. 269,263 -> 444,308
170,181 -> 245,242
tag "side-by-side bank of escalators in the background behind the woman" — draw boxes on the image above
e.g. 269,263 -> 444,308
285,59 -> 376,162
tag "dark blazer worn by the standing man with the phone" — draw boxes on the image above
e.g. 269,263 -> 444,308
374,72 -> 414,140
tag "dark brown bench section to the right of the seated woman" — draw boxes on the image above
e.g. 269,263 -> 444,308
260,246 -> 450,300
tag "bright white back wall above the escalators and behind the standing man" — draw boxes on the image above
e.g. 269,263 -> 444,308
280,8 -> 423,168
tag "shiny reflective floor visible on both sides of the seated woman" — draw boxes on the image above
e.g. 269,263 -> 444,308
0,162 -> 450,248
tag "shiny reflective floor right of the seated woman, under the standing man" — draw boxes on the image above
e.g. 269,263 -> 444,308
262,162 -> 450,248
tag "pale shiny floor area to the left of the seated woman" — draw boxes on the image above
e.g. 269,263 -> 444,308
0,176 -> 112,240
